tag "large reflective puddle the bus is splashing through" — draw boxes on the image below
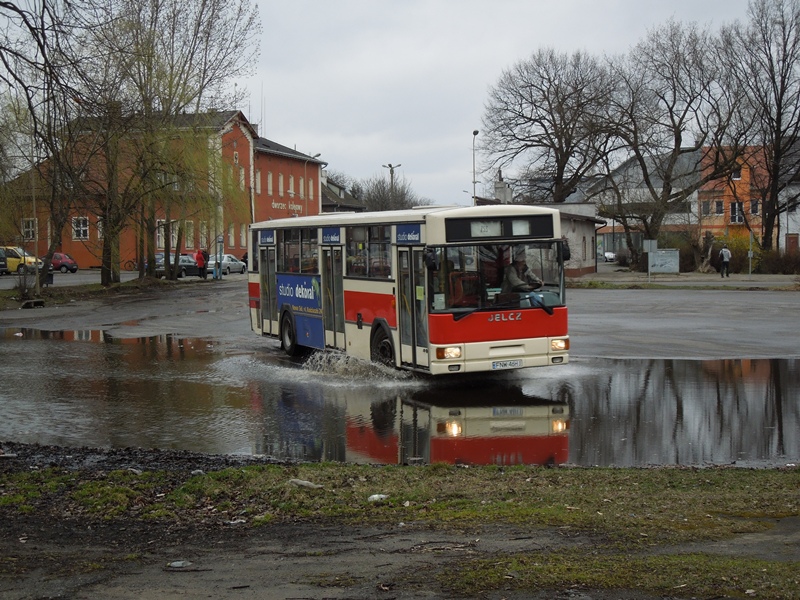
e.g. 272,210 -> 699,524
0,330 -> 800,466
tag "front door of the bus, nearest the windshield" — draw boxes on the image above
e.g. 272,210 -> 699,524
397,247 -> 429,368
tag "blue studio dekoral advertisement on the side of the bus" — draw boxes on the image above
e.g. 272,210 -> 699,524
277,273 -> 325,350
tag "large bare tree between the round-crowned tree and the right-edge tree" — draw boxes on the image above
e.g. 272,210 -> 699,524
604,21 -> 742,251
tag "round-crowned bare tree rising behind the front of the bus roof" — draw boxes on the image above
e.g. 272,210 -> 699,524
482,49 -> 611,202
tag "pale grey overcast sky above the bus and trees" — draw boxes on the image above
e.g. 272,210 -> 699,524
239,0 -> 747,204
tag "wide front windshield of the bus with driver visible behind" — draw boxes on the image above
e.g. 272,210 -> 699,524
427,241 -> 564,313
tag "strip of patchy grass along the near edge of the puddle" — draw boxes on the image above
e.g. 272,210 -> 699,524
0,464 -> 800,547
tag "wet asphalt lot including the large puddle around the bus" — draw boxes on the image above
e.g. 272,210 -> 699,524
0,279 -> 800,466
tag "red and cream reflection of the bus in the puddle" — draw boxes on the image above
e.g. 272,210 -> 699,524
346,388 -> 569,465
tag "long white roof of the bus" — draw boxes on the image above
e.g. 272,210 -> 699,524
250,204 -> 558,229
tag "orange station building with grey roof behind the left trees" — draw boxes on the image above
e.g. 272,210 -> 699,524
6,111 -> 326,268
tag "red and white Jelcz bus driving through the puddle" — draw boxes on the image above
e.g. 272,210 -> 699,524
248,205 -> 569,375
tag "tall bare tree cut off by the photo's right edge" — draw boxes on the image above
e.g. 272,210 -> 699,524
721,0 -> 800,249
